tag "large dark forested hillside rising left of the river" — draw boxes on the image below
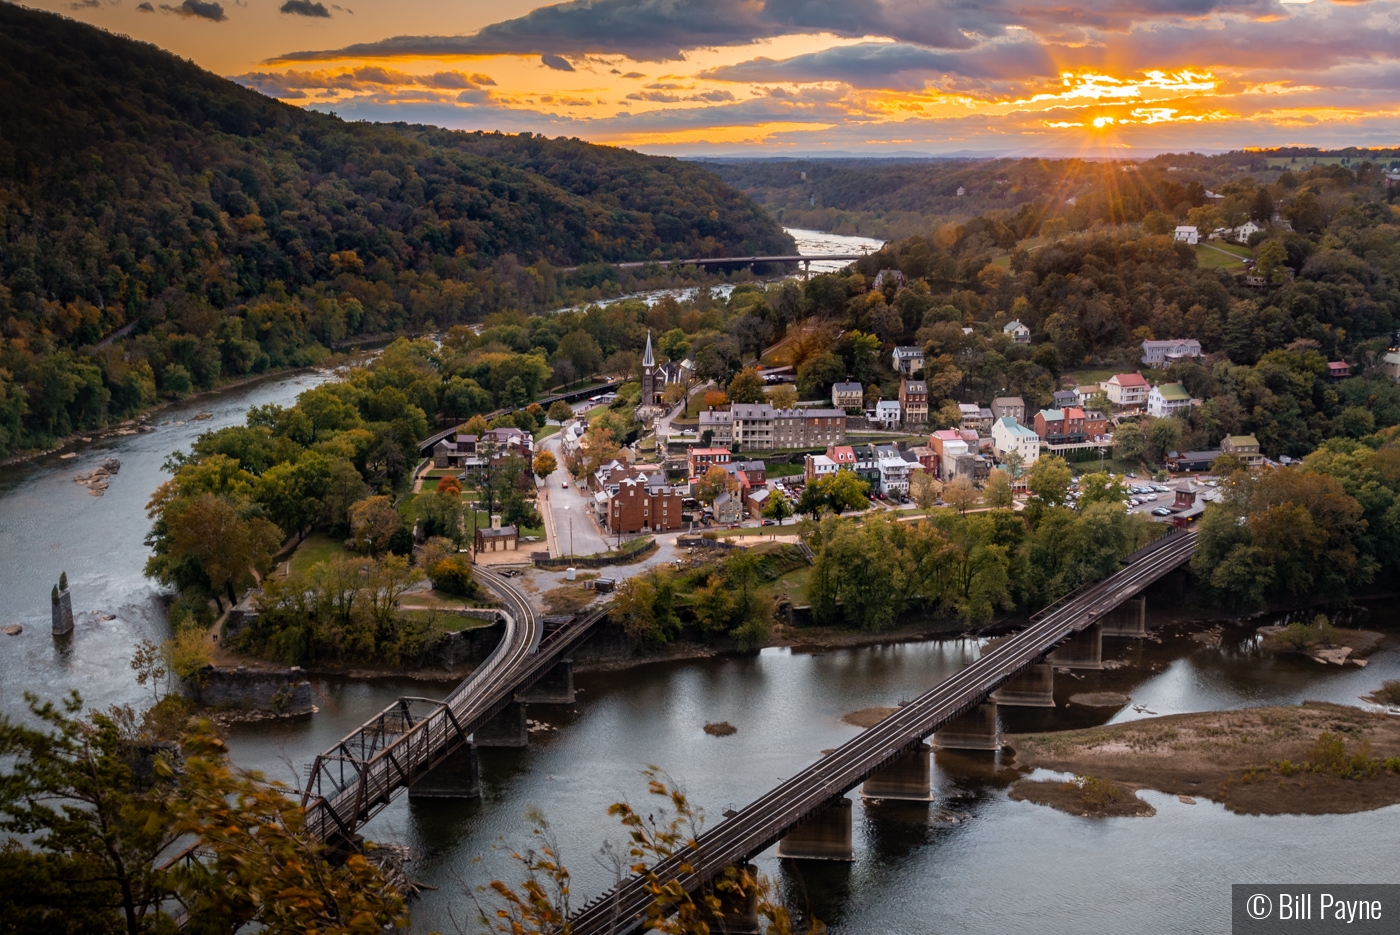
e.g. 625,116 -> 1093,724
0,4 -> 791,454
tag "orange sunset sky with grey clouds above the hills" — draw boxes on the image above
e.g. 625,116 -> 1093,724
29,0 -> 1400,157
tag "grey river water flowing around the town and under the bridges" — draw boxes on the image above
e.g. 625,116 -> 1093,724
0,246 -> 1400,935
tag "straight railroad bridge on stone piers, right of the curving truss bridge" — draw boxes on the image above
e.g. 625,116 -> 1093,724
571,530 -> 1197,935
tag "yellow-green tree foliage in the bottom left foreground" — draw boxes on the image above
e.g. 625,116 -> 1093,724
0,693 -> 406,935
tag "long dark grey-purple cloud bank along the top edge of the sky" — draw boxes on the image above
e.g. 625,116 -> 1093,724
267,0 -> 1288,62
